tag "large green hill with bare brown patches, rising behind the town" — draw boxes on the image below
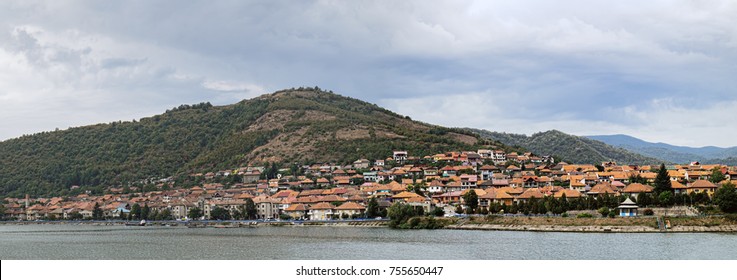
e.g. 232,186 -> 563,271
0,88 -> 479,197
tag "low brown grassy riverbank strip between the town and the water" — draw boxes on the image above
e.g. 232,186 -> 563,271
0,216 -> 737,233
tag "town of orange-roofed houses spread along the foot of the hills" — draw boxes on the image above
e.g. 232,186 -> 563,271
2,150 -> 737,221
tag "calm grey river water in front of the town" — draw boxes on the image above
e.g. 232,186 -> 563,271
0,224 -> 737,260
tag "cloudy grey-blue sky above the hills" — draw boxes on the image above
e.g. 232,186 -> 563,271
0,0 -> 737,146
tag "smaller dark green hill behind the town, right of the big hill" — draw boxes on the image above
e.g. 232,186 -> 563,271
471,129 -> 660,164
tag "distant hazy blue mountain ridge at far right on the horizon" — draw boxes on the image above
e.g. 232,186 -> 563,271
585,134 -> 737,165
